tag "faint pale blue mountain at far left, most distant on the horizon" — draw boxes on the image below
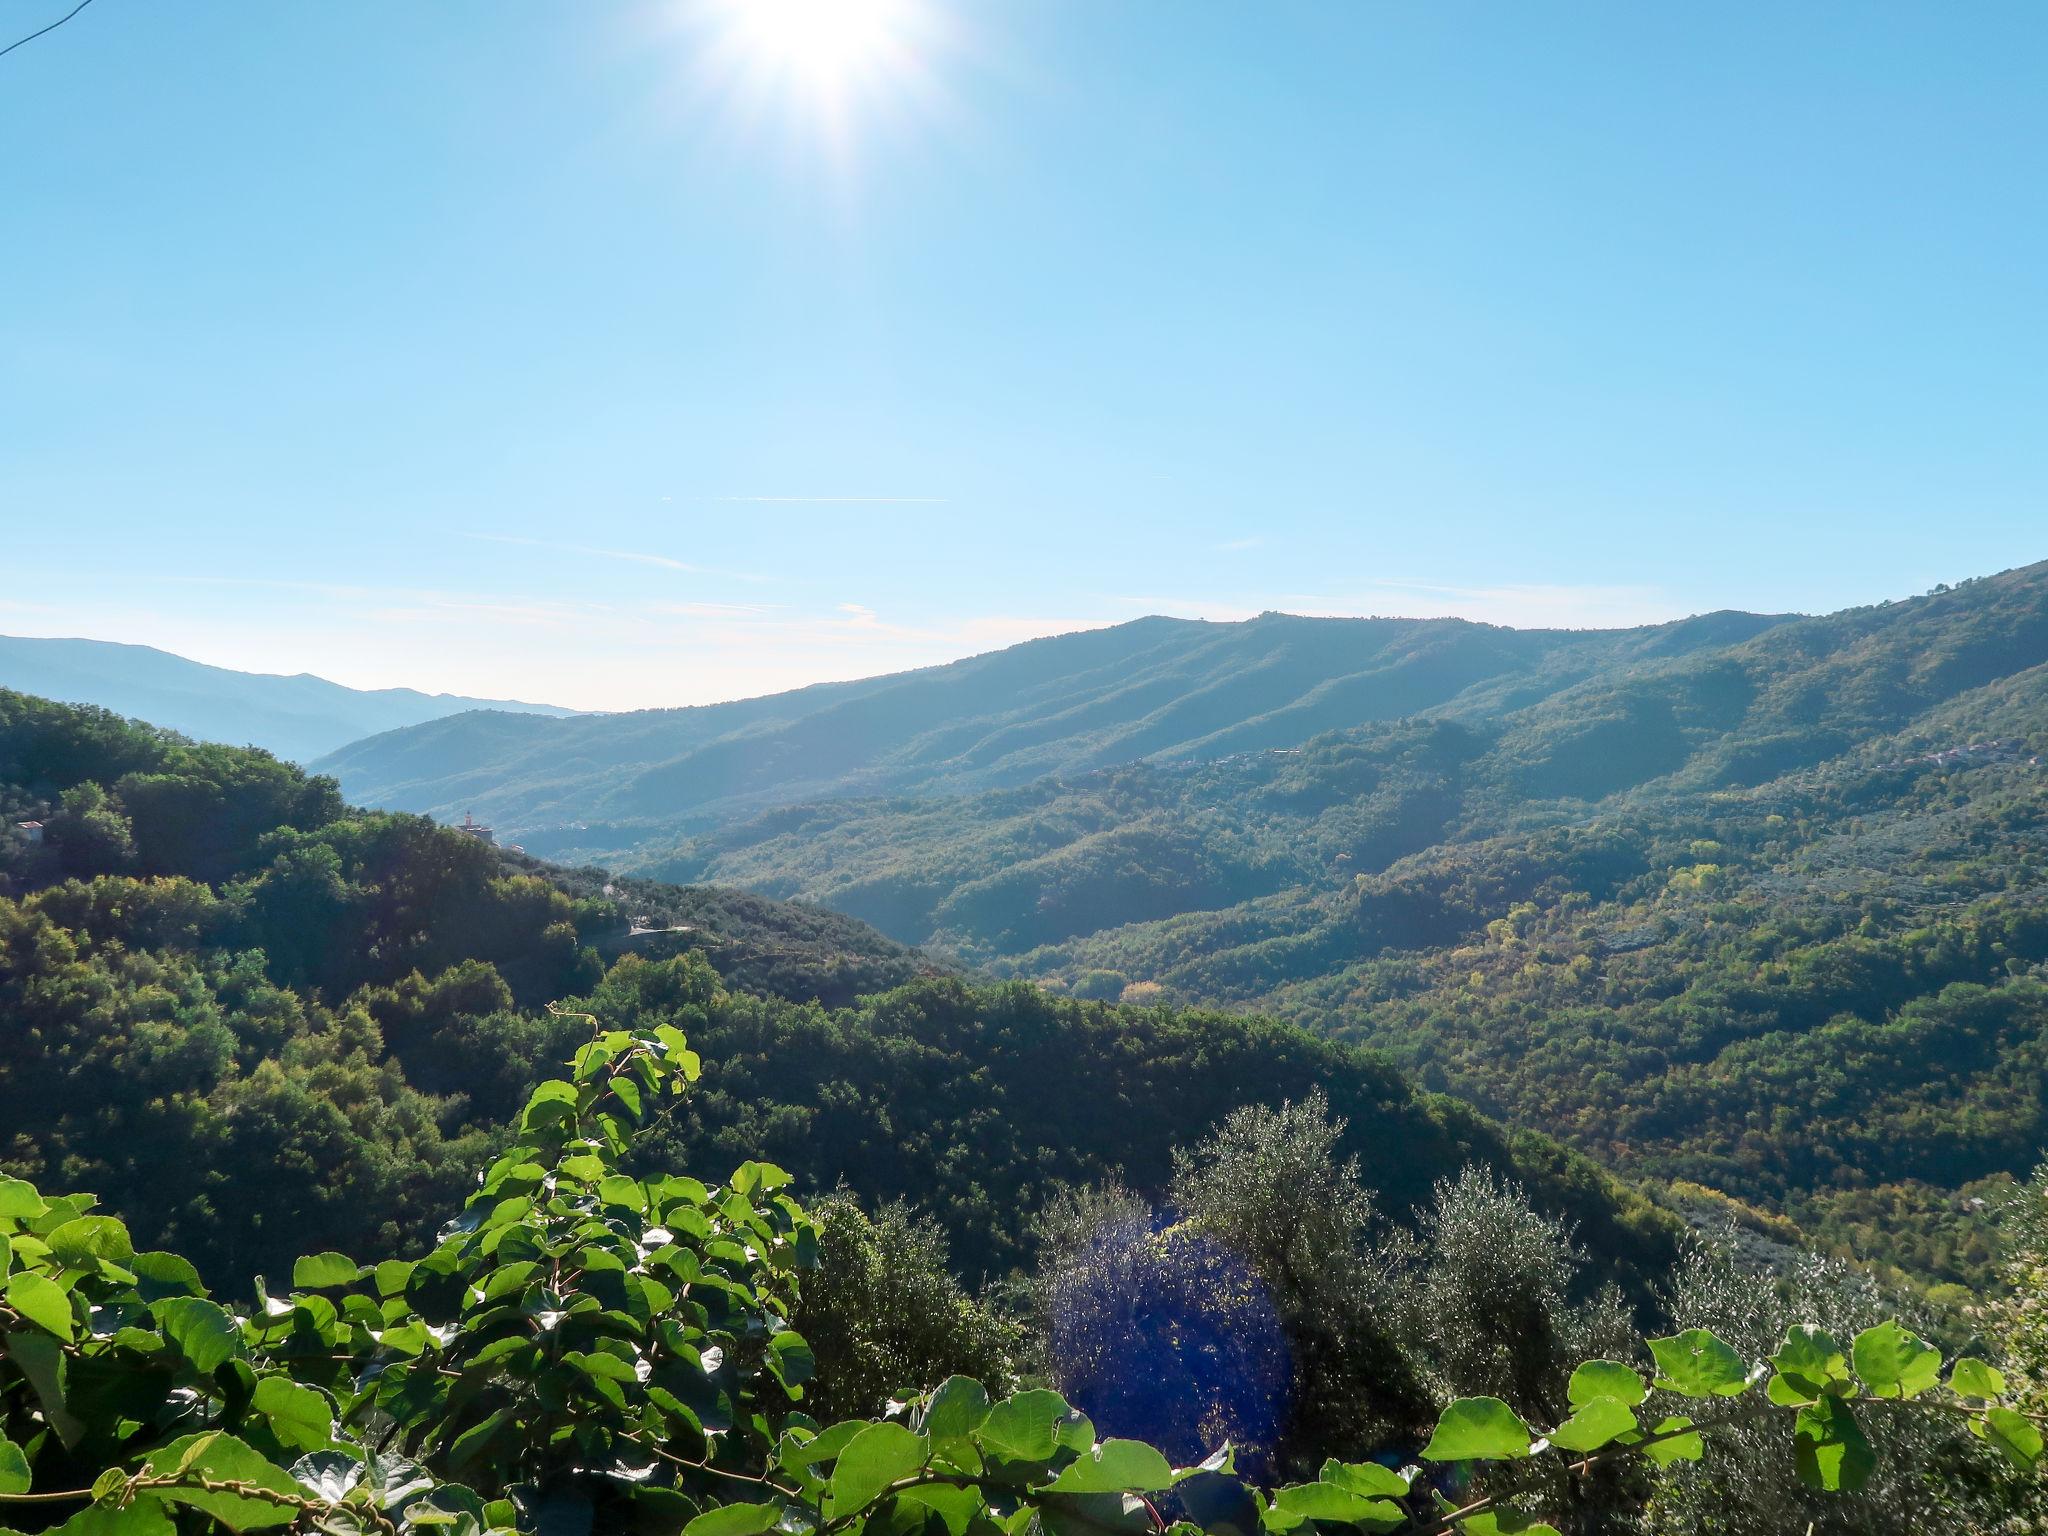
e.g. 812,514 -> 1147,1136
0,635 -> 575,762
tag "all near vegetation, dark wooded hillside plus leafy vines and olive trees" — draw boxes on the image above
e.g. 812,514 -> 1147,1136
0,694 -> 2042,1536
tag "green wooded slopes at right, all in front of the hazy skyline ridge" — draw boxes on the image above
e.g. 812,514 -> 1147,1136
610,565 -> 2048,1280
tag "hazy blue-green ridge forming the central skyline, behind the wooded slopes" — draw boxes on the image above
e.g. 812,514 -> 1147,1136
317,612 -> 1784,852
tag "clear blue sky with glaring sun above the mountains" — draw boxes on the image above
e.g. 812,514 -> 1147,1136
0,0 -> 2048,707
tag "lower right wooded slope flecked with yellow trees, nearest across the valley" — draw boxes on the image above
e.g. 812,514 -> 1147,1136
987,743 -> 2048,1280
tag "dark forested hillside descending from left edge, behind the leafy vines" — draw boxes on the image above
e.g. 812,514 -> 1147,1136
0,694 -> 1673,1296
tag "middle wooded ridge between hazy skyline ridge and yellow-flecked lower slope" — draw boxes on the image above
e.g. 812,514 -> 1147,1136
626,563 -> 2048,950
